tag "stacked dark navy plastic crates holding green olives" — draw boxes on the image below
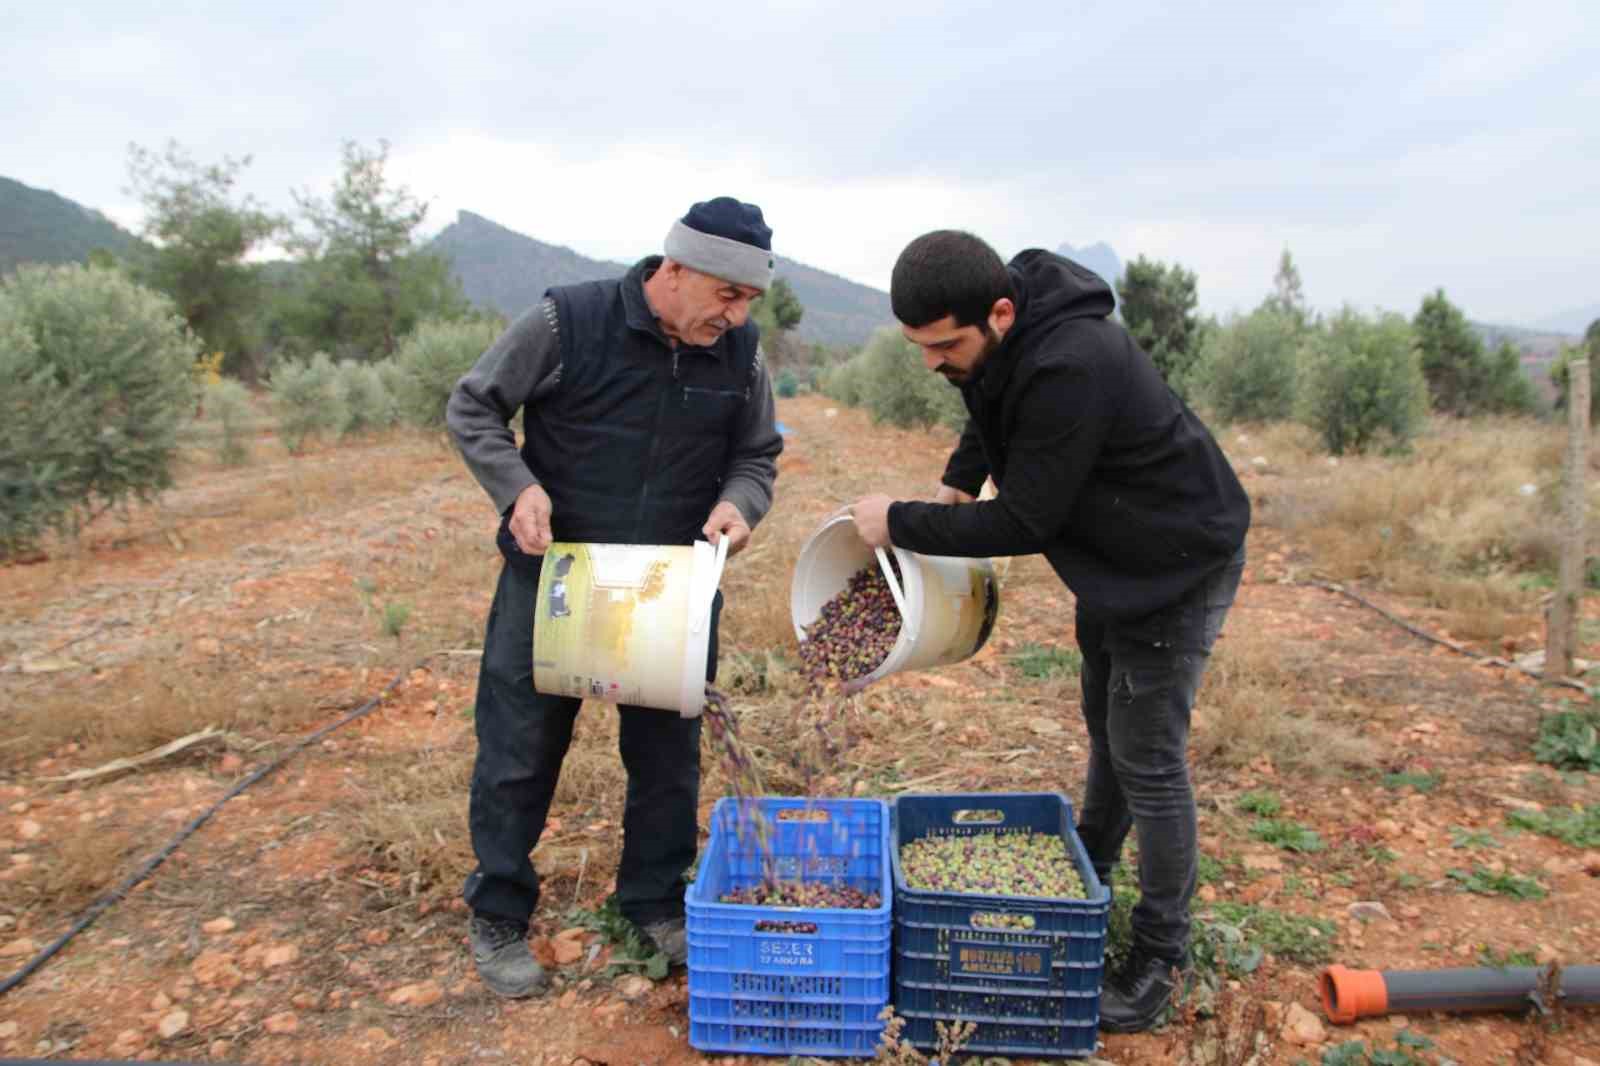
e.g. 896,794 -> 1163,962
890,792 -> 1110,1056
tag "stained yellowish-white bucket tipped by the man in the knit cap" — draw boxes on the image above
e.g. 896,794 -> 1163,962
533,536 -> 728,719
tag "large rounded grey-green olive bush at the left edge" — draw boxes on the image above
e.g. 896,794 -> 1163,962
0,266 -> 197,557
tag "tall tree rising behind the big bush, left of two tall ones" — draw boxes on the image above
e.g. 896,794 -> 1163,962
128,141 -> 285,376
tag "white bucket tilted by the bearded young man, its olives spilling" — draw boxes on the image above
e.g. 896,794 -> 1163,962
789,511 -> 1000,691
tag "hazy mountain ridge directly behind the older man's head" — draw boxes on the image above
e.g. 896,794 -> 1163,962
427,211 -> 894,347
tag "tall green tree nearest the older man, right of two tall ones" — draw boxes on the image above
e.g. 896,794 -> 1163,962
280,141 -> 469,360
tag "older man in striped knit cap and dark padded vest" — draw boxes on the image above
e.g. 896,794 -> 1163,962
448,197 -> 782,997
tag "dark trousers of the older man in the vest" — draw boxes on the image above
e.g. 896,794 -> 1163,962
462,562 -> 722,925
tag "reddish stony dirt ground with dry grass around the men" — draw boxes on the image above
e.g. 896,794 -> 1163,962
0,397 -> 1600,1066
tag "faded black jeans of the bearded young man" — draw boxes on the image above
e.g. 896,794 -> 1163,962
1077,547 -> 1245,959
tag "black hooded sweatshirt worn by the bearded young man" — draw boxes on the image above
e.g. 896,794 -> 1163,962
890,248 -> 1250,621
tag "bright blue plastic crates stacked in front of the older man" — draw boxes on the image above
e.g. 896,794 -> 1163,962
686,797 -> 894,1058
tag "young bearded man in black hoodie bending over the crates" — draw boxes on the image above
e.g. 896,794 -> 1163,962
853,230 -> 1250,1032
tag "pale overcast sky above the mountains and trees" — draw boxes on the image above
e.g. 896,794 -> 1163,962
0,0 -> 1600,323
